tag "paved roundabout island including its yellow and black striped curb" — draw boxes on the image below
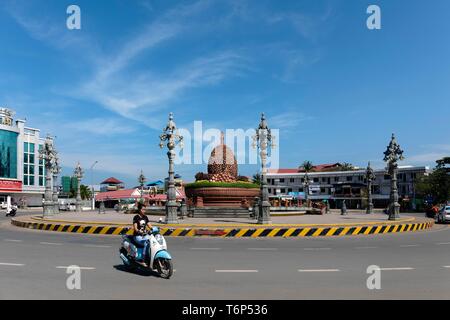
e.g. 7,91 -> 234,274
11,213 -> 434,238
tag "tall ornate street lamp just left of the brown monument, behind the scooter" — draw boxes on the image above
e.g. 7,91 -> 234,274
159,112 -> 183,223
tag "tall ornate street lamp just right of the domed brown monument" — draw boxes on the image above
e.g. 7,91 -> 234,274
253,113 -> 275,224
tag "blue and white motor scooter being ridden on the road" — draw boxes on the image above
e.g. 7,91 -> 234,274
120,227 -> 173,279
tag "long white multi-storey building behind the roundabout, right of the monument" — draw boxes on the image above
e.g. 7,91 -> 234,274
267,165 -> 429,208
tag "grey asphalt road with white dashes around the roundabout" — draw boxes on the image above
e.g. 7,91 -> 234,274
0,222 -> 450,300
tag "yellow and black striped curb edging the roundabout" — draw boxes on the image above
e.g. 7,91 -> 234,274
11,219 -> 434,238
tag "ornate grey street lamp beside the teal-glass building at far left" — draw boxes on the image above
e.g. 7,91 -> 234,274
39,135 -> 57,218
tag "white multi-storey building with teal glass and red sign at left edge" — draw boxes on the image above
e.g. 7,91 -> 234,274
0,108 -> 50,206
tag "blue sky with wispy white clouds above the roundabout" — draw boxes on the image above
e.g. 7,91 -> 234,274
0,0 -> 450,185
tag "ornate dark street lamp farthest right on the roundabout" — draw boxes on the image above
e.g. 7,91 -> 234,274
383,134 -> 405,220
